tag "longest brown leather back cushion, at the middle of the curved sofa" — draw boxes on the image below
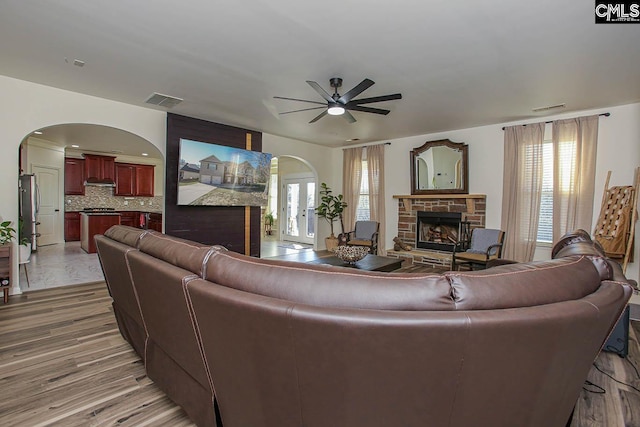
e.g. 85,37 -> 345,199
205,252 -> 454,310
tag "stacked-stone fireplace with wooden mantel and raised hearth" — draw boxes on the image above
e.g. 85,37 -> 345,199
387,194 -> 486,267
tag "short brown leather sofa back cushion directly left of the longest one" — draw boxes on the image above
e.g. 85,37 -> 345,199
138,231 -> 217,277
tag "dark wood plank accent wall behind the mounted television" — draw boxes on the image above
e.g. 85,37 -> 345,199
164,114 -> 262,257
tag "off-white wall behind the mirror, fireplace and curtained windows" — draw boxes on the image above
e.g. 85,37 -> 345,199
356,104 -> 640,280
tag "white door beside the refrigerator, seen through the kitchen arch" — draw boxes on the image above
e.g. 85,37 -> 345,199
32,166 -> 63,246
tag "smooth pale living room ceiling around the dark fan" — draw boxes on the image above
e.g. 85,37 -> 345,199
0,0 -> 640,151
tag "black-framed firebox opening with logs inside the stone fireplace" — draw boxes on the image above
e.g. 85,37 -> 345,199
416,211 -> 469,252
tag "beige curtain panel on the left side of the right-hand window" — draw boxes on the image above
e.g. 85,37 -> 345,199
501,123 -> 545,262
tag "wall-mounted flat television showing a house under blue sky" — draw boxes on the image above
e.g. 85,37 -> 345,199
178,139 -> 271,206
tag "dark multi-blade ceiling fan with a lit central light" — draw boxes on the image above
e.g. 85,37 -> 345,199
274,77 -> 402,123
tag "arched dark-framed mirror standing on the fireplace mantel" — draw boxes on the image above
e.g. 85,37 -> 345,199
411,139 -> 469,195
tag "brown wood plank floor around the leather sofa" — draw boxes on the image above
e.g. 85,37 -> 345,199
0,278 -> 640,427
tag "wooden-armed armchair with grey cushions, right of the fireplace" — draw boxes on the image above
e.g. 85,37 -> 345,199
451,228 -> 504,270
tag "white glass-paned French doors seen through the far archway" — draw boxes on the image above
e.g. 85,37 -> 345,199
280,177 -> 316,245
